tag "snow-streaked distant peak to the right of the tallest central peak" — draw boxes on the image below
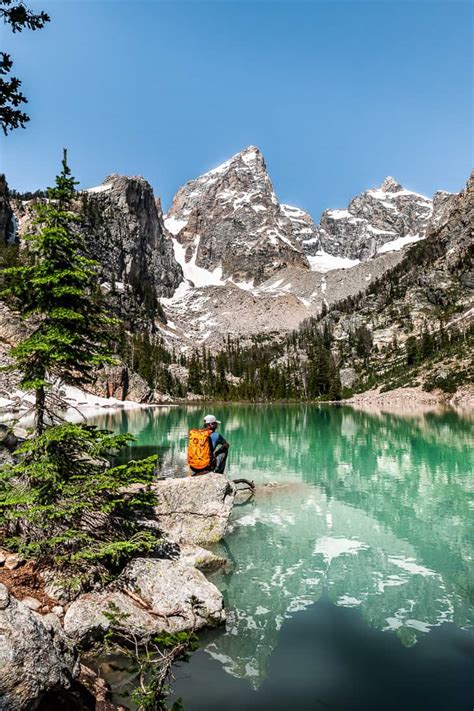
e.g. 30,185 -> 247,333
312,176 -> 433,260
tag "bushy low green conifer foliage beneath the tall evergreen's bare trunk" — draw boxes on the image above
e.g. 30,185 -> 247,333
0,424 -> 160,579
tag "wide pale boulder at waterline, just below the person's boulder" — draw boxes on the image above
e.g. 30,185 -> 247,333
64,558 -> 225,647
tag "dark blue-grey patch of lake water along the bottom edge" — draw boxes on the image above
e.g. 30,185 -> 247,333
173,595 -> 474,711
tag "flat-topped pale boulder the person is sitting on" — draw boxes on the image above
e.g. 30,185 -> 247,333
154,473 -> 235,544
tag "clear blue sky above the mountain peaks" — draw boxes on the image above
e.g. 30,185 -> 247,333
0,0 -> 473,219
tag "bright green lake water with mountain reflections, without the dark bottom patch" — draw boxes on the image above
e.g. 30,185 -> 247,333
90,406 -> 474,687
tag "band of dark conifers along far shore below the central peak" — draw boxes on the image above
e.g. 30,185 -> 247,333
118,327 -> 342,401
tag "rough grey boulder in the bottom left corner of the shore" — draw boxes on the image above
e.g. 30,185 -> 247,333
0,584 -> 79,711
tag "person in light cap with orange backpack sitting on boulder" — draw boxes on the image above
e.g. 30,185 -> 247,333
188,415 -> 229,476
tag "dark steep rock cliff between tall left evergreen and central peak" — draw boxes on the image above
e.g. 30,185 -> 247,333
80,174 -> 183,321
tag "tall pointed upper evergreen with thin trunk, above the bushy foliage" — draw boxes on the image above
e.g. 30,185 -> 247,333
2,150 -> 112,434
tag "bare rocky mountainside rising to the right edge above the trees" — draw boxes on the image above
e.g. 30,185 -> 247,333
327,173 -> 474,364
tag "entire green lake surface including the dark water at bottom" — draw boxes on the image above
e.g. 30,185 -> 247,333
90,405 -> 474,711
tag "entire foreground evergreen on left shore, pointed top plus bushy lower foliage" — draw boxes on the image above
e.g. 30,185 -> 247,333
0,151 -> 160,588
